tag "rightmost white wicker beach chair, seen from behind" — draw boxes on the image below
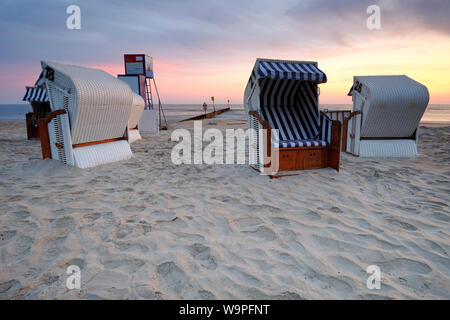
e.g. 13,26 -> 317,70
342,75 -> 429,157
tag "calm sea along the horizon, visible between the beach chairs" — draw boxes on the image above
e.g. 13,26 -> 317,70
0,104 -> 450,125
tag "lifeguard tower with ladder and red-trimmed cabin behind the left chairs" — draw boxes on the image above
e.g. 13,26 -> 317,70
118,54 -> 167,133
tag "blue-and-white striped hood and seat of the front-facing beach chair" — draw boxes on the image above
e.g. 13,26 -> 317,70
244,59 -> 331,148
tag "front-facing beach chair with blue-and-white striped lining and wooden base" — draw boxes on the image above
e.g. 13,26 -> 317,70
244,59 -> 341,175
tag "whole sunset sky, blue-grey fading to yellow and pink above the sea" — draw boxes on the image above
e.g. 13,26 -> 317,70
0,0 -> 450,104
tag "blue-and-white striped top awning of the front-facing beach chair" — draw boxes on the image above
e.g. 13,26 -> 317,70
258,60 -> 327,83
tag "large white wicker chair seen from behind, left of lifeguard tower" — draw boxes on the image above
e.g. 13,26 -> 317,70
39,61 -> 134,168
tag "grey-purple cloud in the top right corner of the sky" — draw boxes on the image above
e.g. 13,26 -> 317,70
288,0 -> 450,35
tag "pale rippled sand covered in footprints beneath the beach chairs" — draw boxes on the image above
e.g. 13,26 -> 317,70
0,119 -> 450,299
